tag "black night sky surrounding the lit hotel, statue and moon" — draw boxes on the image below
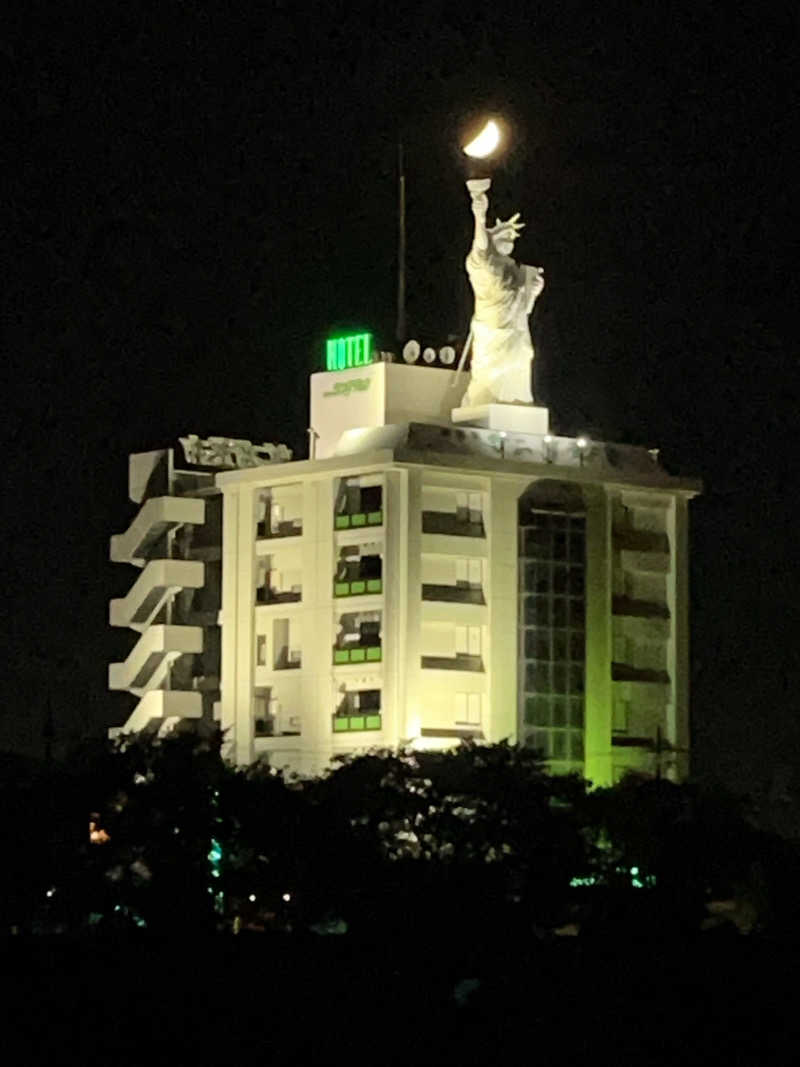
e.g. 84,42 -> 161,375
0,0 -> 800,791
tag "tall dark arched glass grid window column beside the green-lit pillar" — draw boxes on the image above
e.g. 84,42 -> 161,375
518,491 -> 586,773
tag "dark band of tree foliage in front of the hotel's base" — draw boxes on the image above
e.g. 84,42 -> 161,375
0,732 -> 798,935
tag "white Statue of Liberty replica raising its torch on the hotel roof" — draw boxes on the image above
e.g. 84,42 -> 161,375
461,178 -> 544,409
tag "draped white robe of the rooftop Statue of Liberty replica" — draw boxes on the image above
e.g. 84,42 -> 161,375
461,239 -> 538,408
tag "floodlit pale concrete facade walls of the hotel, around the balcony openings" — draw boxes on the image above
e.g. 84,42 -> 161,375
222,446 -> 688,782
